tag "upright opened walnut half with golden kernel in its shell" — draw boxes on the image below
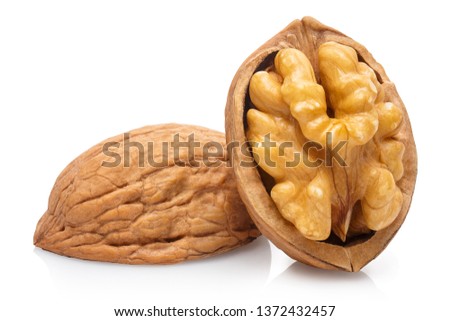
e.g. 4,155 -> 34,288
226,17 -> 417,271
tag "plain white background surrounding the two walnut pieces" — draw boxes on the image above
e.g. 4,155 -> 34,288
0,0 -> 450,321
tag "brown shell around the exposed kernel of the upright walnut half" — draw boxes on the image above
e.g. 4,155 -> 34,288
225,17 -> 417,271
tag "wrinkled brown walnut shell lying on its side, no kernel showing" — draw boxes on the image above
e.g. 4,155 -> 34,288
34,124 -> 259,264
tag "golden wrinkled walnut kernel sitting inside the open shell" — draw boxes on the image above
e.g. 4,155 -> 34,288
247,42 -> 404,241
